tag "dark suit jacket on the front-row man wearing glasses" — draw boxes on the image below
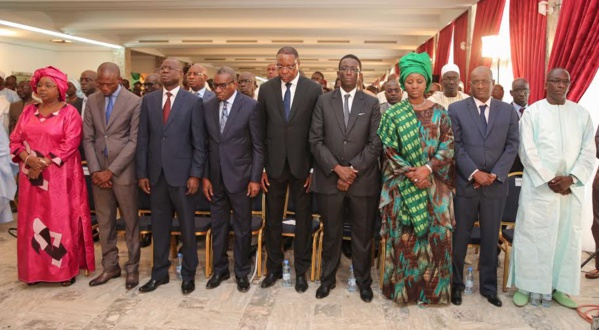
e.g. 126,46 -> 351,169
204,92 -> 264,193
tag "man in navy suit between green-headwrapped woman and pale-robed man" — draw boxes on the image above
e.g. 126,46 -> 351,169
449,67 -> 520,307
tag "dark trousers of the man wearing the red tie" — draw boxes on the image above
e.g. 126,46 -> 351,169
150,173 -> 198,281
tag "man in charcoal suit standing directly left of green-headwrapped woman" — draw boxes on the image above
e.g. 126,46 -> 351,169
310,54 -> 383,302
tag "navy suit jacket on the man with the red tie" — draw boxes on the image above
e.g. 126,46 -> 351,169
137,88 -> 206,187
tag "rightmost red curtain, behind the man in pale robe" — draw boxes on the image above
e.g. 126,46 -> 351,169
549,0 -> 599,102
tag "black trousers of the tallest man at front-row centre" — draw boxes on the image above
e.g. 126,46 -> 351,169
265,162 -> 312,275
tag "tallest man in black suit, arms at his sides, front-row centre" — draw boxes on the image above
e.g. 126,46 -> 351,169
258,47 -> 322,292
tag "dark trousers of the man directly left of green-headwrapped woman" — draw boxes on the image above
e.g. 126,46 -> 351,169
318,192 -> 379,289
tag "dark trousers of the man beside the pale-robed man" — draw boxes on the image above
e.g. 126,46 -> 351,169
452,192 -> 506,296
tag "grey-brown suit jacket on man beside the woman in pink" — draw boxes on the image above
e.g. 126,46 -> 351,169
83,88 -> 141,185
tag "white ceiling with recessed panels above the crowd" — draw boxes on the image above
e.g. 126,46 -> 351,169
0,0 -> 477,82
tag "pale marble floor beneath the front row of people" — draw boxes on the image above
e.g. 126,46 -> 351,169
0,217 -> 599,330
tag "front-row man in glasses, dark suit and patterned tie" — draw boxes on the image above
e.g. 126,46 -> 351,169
202,66 -> 264,292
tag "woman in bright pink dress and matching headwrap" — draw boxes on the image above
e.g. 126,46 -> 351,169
10,66 -> 95,286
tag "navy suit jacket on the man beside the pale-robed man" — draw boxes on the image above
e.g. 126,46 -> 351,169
449,97 -> 520,197
